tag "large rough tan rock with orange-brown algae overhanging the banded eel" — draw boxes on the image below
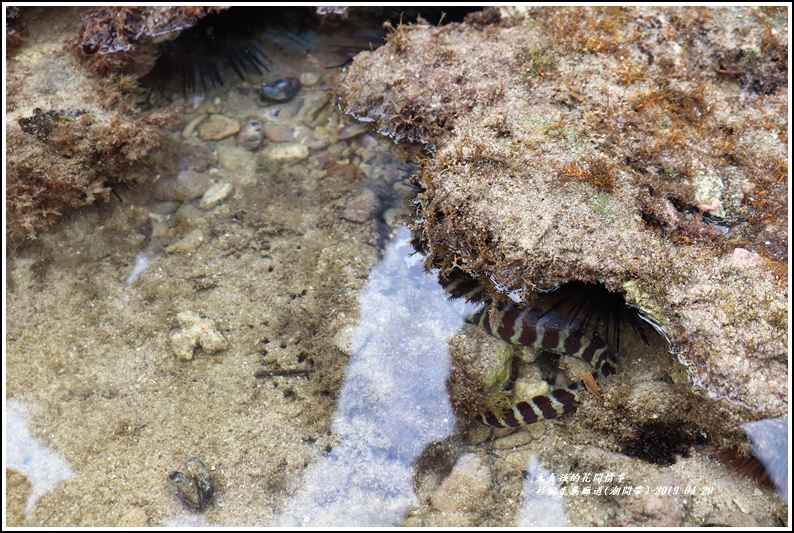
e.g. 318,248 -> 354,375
337,7 -> 788,417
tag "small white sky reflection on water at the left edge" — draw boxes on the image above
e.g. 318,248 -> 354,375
5,400 -> 74,521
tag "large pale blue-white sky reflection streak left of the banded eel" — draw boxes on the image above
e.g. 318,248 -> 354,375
276,228 -> 463,526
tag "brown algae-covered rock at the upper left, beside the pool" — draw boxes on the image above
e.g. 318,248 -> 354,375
6,8 -> 169,236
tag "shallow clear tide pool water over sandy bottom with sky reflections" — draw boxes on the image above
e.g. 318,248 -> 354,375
5,6 -> 787,526
